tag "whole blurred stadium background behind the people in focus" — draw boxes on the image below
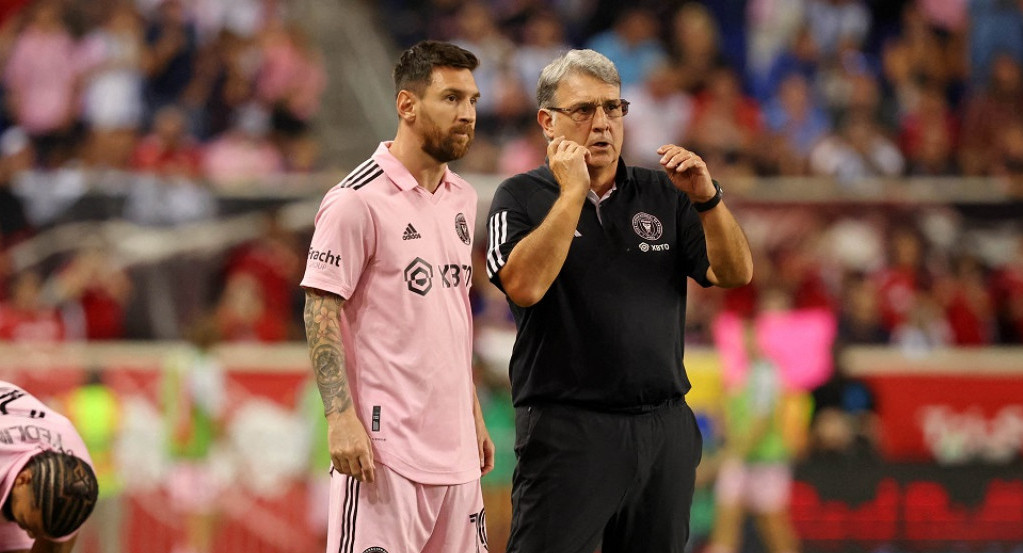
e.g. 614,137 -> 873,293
0,0 -> 1023,553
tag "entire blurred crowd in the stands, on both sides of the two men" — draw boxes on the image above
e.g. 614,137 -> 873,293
0,0 -> 1023,350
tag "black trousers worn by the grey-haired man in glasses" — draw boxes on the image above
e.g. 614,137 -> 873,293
507,403 -> 703,553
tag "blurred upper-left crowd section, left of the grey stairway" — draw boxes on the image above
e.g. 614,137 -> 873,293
0,0 -> 326,187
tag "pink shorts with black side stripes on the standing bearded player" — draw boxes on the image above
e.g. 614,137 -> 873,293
326,464 -> 487,553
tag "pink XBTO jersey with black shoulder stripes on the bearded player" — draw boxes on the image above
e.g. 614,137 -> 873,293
302,142 -> 480,485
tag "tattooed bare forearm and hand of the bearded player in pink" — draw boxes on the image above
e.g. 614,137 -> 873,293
304,288 -> 374,482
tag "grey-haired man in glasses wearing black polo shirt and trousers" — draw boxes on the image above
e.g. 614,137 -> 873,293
487,50 -> 753,553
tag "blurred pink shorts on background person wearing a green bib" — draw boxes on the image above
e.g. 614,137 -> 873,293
714,459 -> 792,513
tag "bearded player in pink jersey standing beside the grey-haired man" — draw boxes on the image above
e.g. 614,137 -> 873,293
302,41 -> 494,553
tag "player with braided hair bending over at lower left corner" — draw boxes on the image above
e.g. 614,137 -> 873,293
0,381 -> 99,553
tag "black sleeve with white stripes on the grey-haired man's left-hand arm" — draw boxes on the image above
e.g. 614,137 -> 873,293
487,177 -> 539,291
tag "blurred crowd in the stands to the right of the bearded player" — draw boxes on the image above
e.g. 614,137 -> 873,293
381,0 -> 1023,350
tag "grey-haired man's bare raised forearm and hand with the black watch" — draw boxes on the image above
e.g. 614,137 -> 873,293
657,144 -> 753,288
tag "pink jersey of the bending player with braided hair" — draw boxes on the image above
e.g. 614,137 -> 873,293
0,380 -> 92,550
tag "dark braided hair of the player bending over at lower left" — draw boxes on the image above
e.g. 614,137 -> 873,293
26,451 -> 99,538
